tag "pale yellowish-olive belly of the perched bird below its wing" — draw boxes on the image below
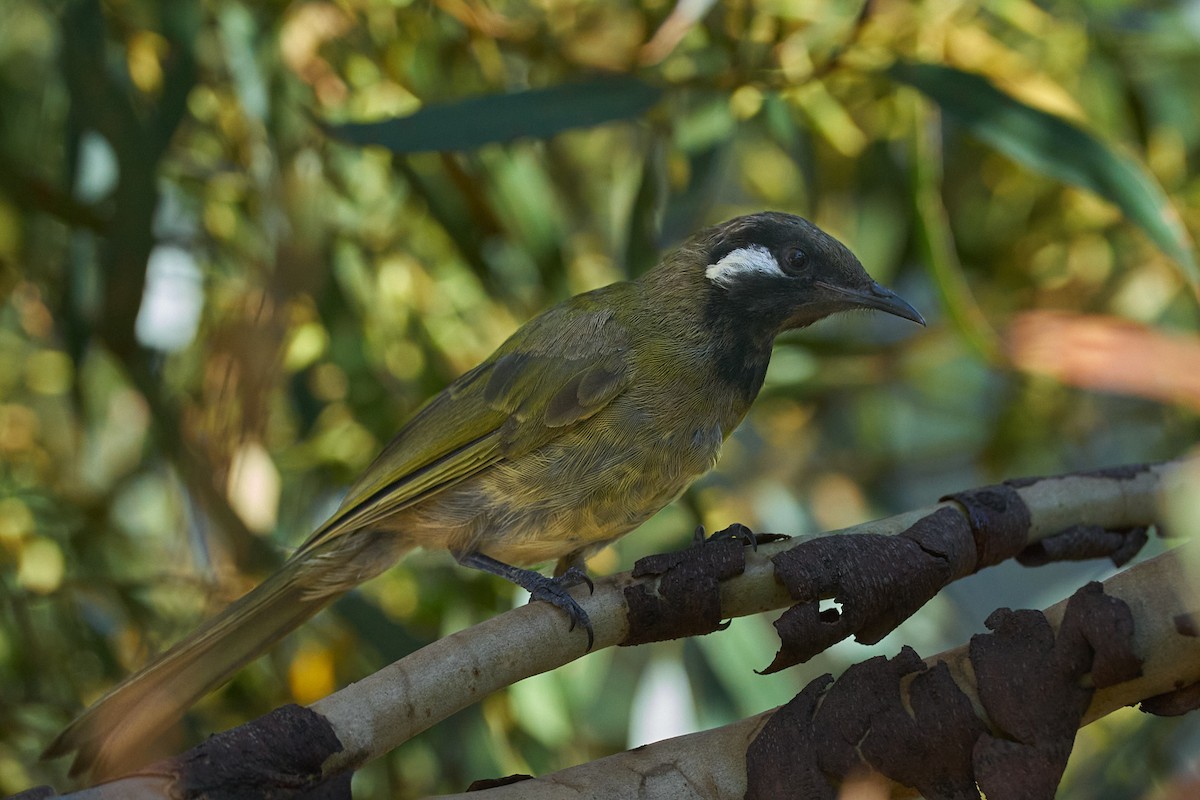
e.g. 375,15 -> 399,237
404,417 -> 722,565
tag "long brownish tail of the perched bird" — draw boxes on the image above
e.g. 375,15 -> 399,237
42,559 -> 340,778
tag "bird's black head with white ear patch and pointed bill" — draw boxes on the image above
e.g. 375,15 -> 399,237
688,211 -> 925,336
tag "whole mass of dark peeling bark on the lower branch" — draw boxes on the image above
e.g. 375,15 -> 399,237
746,583 -> 1132,800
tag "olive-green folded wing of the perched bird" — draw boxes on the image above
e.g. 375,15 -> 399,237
299,293 -> 631,553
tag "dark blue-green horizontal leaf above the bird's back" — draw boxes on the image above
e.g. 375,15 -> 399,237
326,76 -> 662,154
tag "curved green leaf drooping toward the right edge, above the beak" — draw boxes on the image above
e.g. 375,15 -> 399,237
889,62 -> 1200,287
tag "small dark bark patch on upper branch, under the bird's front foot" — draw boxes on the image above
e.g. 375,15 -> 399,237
620,540 -> 745,645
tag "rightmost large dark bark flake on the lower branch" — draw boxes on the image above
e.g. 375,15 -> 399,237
970,583 -> 1141,800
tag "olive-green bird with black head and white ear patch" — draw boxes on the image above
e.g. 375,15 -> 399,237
43,211 -> 925,778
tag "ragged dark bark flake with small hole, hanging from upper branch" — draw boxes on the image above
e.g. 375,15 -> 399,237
763,507 -> 976,674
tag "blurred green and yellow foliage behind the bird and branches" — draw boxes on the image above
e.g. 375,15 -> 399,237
0,0 -> 1200,798
